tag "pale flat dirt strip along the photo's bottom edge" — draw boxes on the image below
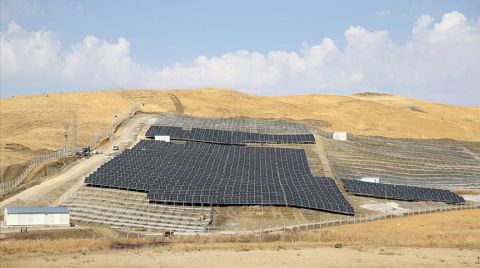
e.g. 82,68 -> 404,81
0,247 -> 480,267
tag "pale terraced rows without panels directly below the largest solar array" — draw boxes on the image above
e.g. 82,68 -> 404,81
62,186 -> 212,232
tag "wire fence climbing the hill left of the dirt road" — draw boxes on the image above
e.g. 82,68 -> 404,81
0,102 -> 140,194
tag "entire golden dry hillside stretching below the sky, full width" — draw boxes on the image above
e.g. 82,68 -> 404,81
0,89 -> 480,180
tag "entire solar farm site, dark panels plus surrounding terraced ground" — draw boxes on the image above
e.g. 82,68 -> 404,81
64,114 -> 478,232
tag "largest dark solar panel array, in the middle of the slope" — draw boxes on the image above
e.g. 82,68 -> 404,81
85,140 -> 354,215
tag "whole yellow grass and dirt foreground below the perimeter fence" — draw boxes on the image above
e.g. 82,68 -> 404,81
0,209 -> 480,267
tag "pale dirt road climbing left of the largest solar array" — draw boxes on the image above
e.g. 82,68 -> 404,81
0,114 -> 154,214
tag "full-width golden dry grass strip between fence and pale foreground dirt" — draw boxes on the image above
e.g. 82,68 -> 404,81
0,210 -> 480,254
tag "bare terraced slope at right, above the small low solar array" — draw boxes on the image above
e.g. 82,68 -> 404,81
325,136 -> 480,188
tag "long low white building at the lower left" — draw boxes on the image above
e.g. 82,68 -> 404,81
3,207 -> 70,226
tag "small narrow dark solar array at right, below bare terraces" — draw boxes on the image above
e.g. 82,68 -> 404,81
342,179 -> 465,204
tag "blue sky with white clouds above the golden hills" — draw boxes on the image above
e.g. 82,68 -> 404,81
0,0 -> 480,105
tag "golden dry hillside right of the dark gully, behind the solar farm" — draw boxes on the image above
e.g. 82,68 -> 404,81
158,89 -> 480,141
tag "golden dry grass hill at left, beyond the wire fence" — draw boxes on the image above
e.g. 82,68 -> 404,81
0,92 -> 135,179
